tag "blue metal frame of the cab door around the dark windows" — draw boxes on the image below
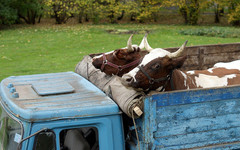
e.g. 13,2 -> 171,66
28,115 -> 125,150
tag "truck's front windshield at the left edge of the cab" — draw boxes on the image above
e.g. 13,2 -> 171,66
0,107 -> 22,150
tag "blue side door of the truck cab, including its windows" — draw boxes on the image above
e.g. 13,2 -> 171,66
27,116 -> 119,150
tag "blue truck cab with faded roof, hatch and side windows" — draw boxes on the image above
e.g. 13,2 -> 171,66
0,72 -> 125,150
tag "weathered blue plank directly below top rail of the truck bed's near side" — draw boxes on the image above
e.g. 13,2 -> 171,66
156,99 -> 240,124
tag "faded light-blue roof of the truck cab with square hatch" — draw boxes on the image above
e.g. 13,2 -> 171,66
0,72 -> 119,121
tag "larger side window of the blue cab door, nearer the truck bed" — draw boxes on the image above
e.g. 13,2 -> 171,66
60,127 -> 99,150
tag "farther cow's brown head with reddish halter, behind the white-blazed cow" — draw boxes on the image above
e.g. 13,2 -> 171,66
92,35 -> 148,77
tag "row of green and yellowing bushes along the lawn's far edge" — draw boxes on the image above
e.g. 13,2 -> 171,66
0,0 -> 240,25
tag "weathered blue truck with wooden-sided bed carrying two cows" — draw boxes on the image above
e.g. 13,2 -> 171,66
0,43 -> 240,150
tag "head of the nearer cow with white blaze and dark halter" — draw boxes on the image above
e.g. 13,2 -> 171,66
122,38 -> 187,90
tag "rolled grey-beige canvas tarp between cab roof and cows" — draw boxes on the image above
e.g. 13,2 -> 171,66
75,55 -> 144,118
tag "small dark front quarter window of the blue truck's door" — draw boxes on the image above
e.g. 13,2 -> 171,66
34,131 -> 56,150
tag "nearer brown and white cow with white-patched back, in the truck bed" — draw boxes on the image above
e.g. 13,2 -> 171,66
122,37 -> 240,91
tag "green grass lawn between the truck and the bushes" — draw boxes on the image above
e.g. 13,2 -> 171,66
0,24 -> 240,80
